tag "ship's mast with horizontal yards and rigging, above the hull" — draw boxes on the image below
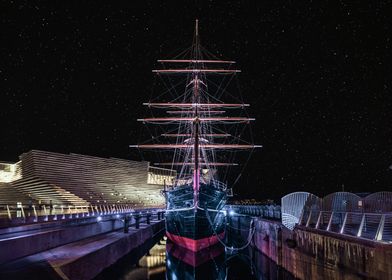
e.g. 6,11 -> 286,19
130,19 -> 261,196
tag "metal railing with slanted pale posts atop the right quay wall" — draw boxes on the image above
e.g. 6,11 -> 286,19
299,211 -> 392,242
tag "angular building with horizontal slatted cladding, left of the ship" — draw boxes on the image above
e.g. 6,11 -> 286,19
0,150 -> 176,207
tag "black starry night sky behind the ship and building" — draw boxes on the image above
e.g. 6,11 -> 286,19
0,1 -> 392,199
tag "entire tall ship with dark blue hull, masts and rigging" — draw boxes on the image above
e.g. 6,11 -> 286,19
130,20 -> 261,252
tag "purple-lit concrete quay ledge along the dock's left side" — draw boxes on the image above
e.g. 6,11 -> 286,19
0,221 -> 165,280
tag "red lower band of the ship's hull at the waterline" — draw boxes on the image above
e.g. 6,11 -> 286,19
166,232 -> 225,252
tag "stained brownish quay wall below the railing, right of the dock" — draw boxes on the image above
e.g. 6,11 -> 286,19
253,218 -> 392,279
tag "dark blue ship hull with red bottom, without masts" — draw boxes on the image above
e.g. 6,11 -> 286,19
166,185 -> 226,252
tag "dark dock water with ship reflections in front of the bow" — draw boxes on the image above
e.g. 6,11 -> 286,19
97,238 -> 294,280
